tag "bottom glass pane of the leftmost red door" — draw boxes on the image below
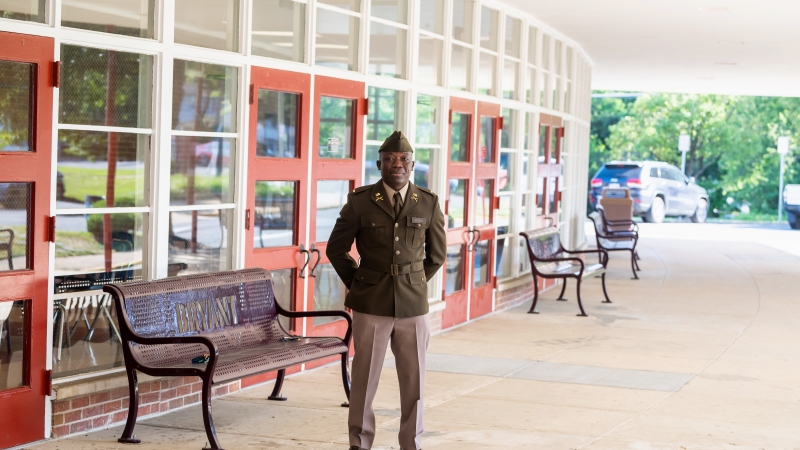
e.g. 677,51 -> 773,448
0,300 -> 30,391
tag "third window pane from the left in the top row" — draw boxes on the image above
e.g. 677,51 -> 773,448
175,0 -> 239,52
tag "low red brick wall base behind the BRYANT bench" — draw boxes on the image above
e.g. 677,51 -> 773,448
52,377 -> 241,438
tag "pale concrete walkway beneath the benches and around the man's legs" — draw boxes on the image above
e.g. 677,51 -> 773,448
32,224 -> 800,450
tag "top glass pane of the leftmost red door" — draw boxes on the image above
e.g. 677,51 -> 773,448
0,61 -> 35,152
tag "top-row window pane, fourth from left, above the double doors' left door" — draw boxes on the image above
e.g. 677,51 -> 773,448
251,0 -> 306,62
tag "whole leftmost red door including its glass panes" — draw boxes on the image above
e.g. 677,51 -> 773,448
0,33 -> 54,448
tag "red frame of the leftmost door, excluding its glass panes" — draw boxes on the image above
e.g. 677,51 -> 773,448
0,32 -> 54,448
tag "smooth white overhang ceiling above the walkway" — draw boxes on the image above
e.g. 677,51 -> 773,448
501,0 -> 800,97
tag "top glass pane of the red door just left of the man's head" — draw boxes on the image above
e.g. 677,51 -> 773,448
317,97 -> 354,159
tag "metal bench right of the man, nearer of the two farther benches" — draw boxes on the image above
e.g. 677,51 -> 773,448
520,227 -> 611,316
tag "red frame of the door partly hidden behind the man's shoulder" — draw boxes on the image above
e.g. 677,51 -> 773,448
305,76 -> 367,356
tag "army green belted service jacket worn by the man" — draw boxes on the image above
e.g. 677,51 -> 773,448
326,181 -> 447,318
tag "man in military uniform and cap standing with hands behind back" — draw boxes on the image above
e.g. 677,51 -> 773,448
327,131 -> 446,450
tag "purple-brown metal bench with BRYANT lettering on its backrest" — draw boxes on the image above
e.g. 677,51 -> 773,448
103,269 -> 352,449
